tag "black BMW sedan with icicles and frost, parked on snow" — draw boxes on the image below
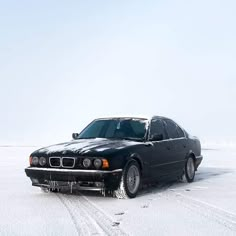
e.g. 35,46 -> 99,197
25,116 -> 202,198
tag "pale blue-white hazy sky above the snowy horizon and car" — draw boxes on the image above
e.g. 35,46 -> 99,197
0,0 -> 236,144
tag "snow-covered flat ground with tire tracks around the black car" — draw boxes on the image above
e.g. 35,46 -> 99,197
0,147 -> 236,236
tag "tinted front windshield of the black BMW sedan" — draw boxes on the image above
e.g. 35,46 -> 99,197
78,118 -> 147,140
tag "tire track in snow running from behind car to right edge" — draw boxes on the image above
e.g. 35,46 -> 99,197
166,190 -> 236,232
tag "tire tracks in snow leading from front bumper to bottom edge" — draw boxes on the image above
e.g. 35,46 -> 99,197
57,193 -> 128,236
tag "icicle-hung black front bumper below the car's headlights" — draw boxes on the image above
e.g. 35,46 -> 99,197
25,167 -> 122,190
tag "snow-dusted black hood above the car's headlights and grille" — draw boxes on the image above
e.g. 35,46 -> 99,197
32,138 -> 140,156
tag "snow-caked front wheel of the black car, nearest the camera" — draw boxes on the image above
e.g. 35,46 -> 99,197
114,160 -> 141,199
